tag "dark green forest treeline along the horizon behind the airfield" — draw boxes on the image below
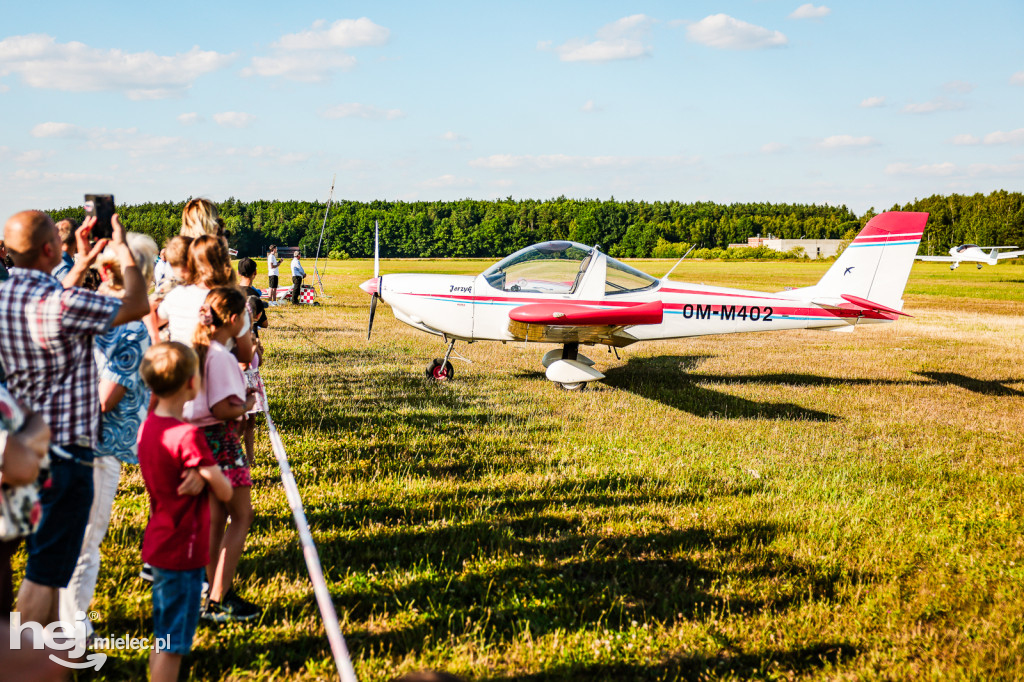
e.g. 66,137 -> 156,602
51,191 -> 1024,258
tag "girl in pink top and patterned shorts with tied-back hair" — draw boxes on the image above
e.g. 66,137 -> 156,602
185,287 -> 260,622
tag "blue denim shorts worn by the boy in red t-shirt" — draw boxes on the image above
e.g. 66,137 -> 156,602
153,566 -> 206,656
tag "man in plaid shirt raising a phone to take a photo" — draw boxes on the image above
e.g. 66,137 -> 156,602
0,211 -> 150,624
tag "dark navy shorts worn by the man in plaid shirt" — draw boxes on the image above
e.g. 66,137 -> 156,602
25,445 -> 93,588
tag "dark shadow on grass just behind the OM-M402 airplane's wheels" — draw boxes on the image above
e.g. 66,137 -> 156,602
604,355 -> 842,422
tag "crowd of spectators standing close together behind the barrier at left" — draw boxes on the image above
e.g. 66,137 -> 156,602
0,199 -> 267,680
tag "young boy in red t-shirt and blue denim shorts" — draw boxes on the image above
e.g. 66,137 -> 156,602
138,342 -> 231,682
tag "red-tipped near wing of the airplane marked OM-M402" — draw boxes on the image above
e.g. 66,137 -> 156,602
509,301 -> 665,346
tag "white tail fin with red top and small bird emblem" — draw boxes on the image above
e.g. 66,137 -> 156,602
794,211 -> 928,310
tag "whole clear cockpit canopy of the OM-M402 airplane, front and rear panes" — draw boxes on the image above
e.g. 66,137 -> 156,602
483,241 -> 658,294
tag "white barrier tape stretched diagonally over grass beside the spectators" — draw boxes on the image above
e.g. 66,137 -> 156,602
263,400 -> 357,682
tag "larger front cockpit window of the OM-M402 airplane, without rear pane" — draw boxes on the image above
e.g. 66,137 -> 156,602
483,242 -> 594,294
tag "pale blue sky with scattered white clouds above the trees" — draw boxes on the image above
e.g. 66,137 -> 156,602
0,0 -> 1024,216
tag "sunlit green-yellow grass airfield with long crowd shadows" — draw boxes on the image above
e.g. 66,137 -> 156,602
70,260 -> 1024,681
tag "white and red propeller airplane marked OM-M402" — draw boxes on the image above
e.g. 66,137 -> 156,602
359,212 -> 928,390
